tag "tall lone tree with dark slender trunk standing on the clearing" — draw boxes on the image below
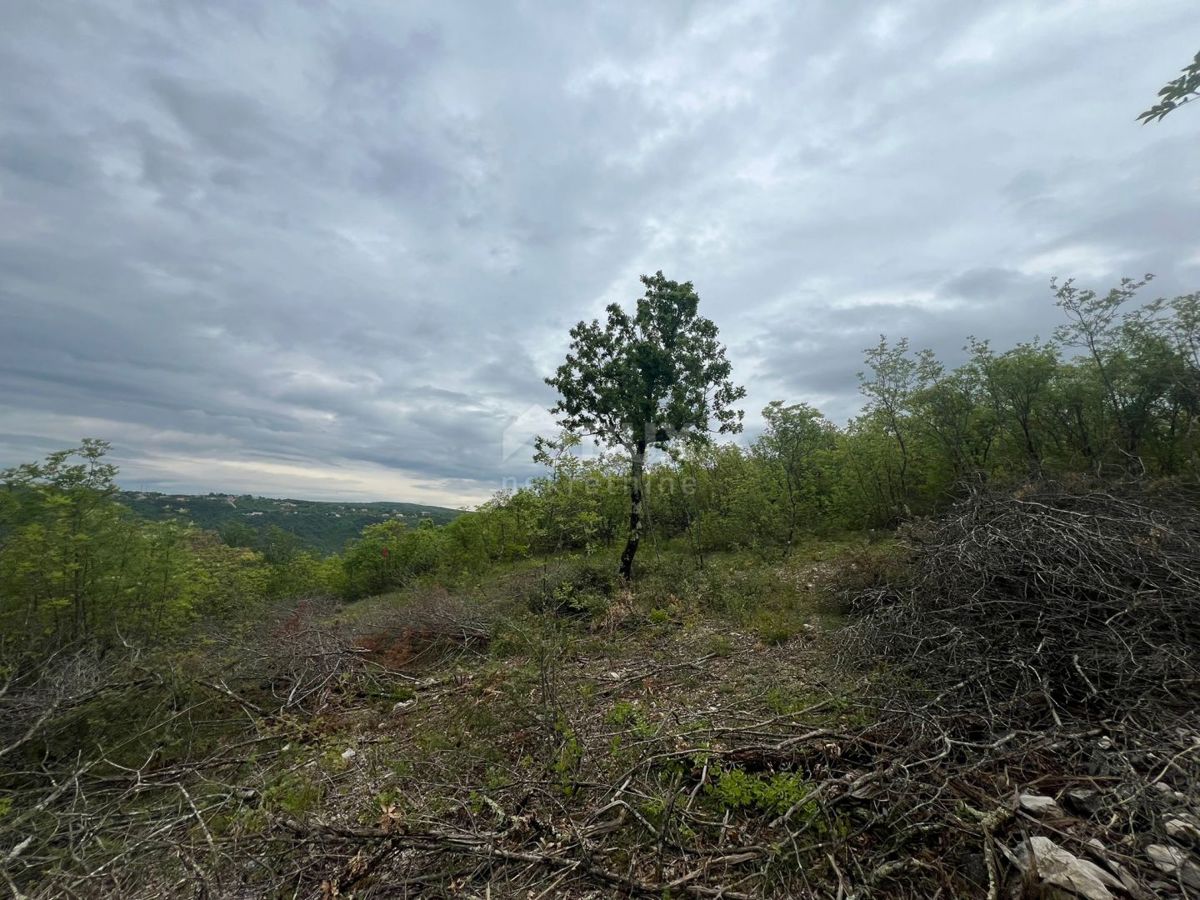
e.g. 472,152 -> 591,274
546,271 -> 745,580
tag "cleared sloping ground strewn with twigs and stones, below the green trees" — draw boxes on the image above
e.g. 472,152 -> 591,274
8,497 -> 1200,900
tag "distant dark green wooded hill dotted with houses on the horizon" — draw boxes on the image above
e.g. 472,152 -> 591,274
118,491 -> 460,553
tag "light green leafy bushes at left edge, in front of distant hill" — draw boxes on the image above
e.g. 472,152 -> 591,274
0,439 -> 331,665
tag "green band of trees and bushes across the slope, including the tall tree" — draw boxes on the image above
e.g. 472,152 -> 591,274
0,272 -> 1200,658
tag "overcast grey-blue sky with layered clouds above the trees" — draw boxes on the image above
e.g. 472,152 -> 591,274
0,0 -> 1200,505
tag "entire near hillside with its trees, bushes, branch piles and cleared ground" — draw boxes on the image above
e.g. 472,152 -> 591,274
0,272 -> 1200,898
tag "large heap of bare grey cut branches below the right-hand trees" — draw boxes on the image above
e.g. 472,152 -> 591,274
848,485 -> 1200,724
